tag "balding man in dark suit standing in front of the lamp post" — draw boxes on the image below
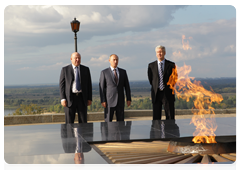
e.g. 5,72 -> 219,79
59,52 -> 92,123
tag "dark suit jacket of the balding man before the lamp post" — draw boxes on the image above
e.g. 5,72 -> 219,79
59,64 -> 92,107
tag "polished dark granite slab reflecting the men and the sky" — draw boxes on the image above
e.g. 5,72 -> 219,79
4,117 -> 238,170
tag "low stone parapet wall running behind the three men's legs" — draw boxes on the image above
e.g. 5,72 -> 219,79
4,109 -> 238,125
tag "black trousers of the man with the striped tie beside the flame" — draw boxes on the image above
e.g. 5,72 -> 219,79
153,89 -> 175,120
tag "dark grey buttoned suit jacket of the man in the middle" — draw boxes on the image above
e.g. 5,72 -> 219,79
99,67 -> 131,107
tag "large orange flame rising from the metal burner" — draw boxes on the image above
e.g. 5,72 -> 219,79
167,64 -> 223,143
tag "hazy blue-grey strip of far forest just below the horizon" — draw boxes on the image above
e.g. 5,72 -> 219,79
4,77 -> 238,93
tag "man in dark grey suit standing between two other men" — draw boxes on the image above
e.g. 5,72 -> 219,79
99,54 -> 131,122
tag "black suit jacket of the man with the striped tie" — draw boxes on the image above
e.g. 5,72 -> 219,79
148,59 -> 175,103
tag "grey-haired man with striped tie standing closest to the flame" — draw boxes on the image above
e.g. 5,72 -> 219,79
148,45 -> 175,120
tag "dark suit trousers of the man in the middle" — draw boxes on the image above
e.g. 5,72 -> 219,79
104,104 -> 124,122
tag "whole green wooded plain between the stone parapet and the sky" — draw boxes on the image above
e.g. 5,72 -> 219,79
4,78 -> 238,113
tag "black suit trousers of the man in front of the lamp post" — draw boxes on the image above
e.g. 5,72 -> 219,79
64,93 -> 87,124
